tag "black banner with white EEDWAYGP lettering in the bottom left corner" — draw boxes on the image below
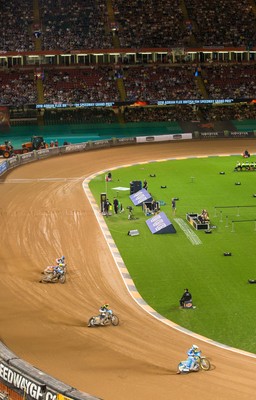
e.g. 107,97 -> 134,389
0,361 -> 57,400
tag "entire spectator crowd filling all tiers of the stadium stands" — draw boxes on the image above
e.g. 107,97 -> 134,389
0,0 -> 256,123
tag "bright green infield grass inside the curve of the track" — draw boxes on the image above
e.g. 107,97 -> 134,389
89,156 -> 256,352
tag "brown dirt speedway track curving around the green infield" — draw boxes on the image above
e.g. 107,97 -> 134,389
0,140 -> 256,400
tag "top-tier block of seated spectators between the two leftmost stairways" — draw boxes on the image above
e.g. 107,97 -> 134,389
39,0 -> 112,50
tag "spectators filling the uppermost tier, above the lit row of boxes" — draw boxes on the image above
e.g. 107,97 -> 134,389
0,0 -> 256,51
